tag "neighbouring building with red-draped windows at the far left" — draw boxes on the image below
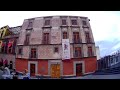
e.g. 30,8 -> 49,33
0,26 -> 21,69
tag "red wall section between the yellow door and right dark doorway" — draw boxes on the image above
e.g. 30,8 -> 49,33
63,60 -> 73,75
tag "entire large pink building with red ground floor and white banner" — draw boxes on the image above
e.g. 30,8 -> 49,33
15,16 -> 97,78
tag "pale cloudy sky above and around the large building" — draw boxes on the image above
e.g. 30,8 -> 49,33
0,11 -> 120,56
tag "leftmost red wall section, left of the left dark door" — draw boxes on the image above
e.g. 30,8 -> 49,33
15,59 -> 28,72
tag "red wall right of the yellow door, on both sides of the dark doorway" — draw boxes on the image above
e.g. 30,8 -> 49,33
63,57 -> 97,75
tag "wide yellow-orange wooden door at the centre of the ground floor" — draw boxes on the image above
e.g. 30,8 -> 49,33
51,64 -> 60,78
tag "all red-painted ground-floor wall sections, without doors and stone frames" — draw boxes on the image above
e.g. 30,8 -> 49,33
15,57 -> 97,75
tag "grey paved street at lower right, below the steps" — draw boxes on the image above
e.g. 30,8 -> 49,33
66,74 -> 120,79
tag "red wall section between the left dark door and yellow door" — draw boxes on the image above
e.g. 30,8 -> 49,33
38,60 -> 48,75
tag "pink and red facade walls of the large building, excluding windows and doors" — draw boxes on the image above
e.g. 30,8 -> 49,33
16,16 -> 96,76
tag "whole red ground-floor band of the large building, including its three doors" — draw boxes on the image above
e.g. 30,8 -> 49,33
15,56 -> 97,78
